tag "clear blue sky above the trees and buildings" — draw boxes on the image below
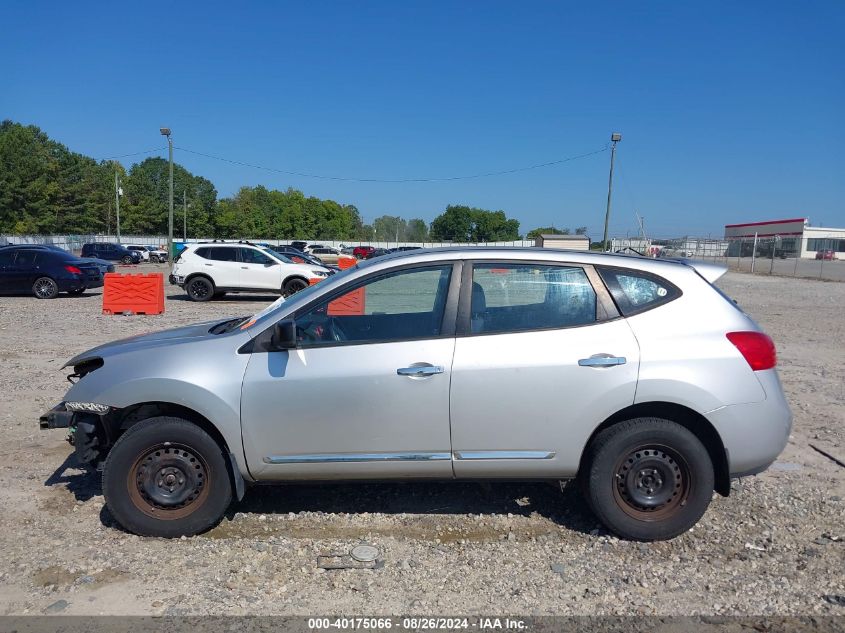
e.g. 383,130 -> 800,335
0,1 -> 845,239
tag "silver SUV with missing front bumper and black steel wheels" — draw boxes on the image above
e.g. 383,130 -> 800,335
41,248 -> 792,540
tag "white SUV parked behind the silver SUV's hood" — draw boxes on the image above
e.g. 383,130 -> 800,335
170,242 -> 330,301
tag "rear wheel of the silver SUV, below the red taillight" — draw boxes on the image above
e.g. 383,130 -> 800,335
582,418 -> 714,541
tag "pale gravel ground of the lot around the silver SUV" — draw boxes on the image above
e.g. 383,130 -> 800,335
0,267 -> 845,615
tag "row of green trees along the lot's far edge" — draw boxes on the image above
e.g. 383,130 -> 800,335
0,120 -> 572,242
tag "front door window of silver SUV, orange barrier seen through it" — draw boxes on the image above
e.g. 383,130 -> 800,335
296,264 -> 452,347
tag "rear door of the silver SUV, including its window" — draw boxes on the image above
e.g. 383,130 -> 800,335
450,261 -> 639,477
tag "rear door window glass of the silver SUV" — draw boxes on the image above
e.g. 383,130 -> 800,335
470,263 -> 596,334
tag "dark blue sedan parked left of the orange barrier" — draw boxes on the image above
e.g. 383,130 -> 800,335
0,246 -> 103,299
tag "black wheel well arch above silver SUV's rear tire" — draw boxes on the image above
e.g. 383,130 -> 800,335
578,402 -> 731,497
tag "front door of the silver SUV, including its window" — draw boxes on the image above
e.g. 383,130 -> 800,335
241,262 -> 459,479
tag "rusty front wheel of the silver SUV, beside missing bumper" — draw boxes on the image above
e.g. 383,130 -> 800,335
103,416 -> 232,538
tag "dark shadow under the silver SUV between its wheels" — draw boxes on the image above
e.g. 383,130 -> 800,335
221,482 -> 597,534
